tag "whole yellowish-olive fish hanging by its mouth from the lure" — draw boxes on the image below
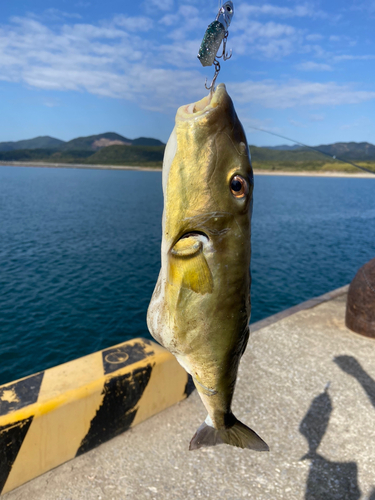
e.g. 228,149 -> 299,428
147,83 -> 268,451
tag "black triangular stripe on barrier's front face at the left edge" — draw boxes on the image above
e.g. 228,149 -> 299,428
0,417 -> 34,493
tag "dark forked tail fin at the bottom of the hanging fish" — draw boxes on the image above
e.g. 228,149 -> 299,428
189,419 -> 269,451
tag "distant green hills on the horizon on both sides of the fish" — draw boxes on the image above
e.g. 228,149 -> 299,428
0,137 -> 375,172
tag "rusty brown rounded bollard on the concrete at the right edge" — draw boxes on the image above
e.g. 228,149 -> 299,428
345,259 -> 375,338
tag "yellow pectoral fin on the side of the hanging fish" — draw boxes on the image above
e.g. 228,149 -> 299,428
168,238 -> 213,295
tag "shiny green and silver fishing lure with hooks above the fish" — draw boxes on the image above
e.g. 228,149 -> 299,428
198,1 -> 234,91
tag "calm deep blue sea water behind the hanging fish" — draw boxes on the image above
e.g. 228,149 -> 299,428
0,167 -> 375,384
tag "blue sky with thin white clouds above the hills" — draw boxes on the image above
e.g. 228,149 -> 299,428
0,0 -> 375,146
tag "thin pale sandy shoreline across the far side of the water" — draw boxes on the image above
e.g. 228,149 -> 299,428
0,161 -> 375,179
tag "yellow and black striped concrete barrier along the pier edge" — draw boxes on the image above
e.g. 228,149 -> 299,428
0,338 -> 192,493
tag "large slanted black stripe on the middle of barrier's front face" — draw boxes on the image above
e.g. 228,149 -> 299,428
76,365 -> 153,456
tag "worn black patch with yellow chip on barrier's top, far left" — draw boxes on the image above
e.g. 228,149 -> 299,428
0,372 -> 44,415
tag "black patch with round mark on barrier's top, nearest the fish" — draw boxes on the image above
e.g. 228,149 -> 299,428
102,339 -> 155,375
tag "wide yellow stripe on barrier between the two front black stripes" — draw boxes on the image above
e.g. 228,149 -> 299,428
3,352 -> 104,493
